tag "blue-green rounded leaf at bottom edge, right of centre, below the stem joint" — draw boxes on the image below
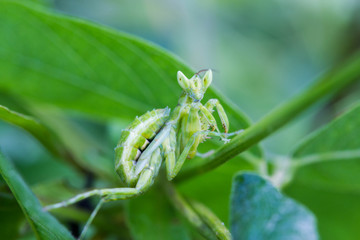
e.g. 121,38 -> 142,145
230,173 -> 318,240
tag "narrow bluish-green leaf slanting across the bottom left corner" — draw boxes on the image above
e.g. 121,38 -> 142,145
0,154 -> 74,239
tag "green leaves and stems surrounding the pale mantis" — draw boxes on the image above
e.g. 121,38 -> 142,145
0,0 -> 360,239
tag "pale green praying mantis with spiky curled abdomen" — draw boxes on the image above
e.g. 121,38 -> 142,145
45,69 -> 239,239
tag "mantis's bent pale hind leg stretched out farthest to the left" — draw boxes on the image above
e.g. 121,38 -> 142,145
44,148 -> 162,211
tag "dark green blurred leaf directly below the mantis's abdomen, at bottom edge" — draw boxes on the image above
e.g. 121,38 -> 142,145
126,186 -> 190,240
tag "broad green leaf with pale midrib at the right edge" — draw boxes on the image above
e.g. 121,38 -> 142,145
284,104 -> 360,240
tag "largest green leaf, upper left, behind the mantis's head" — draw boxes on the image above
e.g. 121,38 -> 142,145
0,1 -> 253,132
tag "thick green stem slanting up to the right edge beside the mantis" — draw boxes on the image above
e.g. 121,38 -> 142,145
176,54 -> 360,181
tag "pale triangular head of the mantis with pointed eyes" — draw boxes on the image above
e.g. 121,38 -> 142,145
177,69 -> 212,102
